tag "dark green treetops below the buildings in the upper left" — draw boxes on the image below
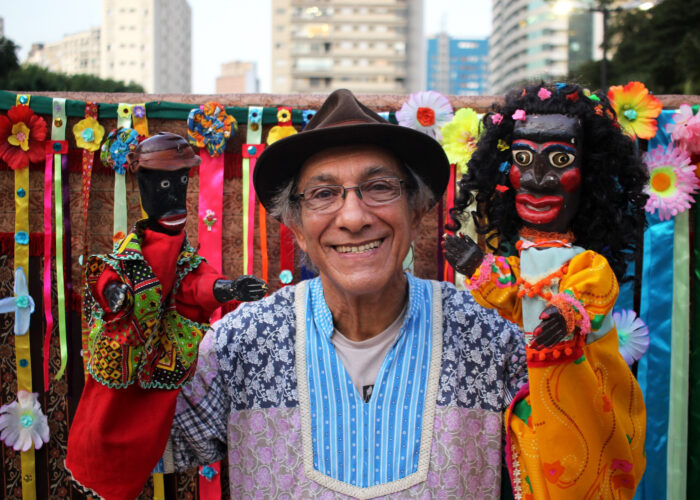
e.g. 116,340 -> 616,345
0,38 -> 143,93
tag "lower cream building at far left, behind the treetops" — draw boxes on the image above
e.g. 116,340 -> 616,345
27,28 -> 100,76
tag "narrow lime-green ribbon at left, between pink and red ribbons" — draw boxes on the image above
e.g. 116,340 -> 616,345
52,97 -> 68,380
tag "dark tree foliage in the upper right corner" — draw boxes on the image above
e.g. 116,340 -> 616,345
569,0 -> 700,94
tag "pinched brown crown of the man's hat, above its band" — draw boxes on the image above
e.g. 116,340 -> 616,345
302,89 -> 389,133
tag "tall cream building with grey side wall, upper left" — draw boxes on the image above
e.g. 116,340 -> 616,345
100,0 -> 192,93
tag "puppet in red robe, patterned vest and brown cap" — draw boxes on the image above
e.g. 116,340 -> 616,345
66,133 -> 267,499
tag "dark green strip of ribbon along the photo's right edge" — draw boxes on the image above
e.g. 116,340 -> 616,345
687,196 -> 700,491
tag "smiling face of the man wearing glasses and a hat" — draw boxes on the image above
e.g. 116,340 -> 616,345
292,146 -> 420,296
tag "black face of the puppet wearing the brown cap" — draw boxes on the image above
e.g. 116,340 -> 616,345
138,167 -> 190,234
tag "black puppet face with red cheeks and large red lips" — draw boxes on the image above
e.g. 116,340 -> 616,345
510,114 -> 583,233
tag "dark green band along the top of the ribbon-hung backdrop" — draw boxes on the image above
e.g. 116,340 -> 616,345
0,90 -> 397,125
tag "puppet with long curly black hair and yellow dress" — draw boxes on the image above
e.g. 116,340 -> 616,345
443,84 -> 647,498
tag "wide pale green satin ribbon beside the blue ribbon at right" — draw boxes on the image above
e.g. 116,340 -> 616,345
666,211 -> 690,500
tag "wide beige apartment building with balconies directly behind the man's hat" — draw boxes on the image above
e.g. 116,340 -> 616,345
271,0 -> 425,94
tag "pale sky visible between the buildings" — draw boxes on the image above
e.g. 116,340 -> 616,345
0,0 -> 491,94
